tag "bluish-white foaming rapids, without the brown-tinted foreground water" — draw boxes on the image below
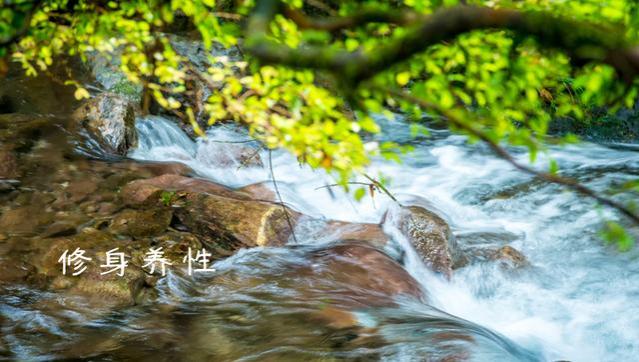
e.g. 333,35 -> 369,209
132,119 -> 639,361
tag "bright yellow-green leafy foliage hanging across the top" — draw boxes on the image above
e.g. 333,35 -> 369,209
0,0 -> 639,246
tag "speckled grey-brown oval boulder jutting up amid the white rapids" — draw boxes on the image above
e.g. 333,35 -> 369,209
393,206 -> 461,278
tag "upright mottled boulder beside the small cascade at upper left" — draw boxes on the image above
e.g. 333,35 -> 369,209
73,93 -> 137,155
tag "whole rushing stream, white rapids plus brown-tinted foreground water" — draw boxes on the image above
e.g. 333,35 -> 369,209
0,117 -> 639,361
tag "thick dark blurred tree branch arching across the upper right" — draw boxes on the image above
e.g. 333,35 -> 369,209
246,0 -> 639,85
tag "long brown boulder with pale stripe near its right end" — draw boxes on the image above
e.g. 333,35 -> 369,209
121,175 -> 300,255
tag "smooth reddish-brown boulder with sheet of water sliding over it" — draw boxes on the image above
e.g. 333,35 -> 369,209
211,241 -> 427,311
